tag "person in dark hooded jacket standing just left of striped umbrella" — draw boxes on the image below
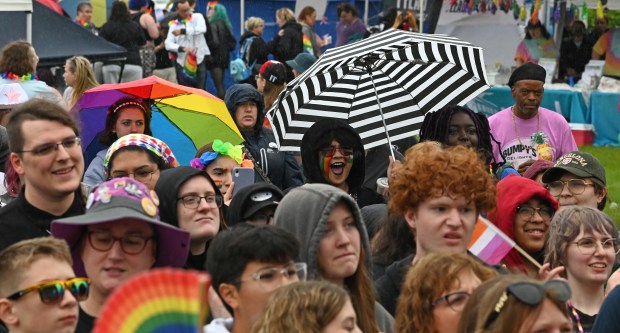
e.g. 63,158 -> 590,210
225,83 -> 303,191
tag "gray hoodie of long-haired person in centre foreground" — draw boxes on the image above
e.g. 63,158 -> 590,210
273,184 -> 394,333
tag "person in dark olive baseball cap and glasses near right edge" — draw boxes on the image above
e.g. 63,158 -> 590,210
542,151 -> 607,210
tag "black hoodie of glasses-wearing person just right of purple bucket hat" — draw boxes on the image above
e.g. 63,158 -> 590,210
155,166 -> 224,271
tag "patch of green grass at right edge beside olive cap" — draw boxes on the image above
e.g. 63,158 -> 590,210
579,146 -> 620,227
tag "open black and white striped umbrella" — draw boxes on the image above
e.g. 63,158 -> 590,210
267,29 -> 489,151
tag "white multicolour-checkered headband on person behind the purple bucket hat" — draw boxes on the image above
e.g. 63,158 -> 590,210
103,134 -> 179,175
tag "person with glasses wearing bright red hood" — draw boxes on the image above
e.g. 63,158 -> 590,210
488,175 -> 558,277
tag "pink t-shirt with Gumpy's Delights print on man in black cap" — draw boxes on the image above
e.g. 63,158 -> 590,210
489,107 -> 577,168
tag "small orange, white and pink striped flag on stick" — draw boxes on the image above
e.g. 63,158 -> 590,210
467,216 -> 516,265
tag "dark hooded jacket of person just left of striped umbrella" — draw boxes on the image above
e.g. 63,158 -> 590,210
224,84 -> 303,191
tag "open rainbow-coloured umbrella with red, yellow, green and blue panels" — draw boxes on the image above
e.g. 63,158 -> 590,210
77,76 -> 243,165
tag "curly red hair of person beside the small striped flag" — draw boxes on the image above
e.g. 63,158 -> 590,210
390,141 -> 495,214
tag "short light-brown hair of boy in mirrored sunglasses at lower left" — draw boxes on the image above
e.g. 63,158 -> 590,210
0,237 -> 73,298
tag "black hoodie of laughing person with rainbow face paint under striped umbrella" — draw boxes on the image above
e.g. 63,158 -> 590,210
301,118 -> 384,208
